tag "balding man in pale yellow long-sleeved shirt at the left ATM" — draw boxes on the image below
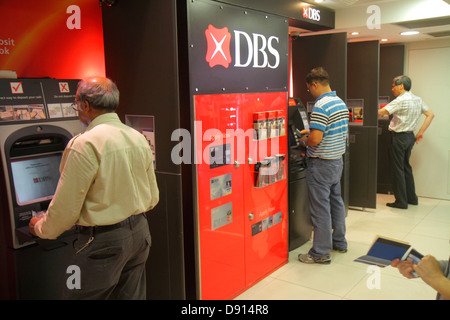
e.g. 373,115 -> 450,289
30,77 -> 159,299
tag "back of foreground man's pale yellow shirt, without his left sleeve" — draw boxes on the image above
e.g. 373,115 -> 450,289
66,113 -> 159,225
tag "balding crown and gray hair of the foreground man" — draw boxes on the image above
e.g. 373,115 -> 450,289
77,77 -> 119,112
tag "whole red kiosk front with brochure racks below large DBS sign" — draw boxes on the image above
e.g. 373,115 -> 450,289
194,92 -> 288,299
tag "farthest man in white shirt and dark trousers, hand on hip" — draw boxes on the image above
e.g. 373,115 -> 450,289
378,75 -> 434,209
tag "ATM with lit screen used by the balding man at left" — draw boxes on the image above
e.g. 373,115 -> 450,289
0,79 -> 83,299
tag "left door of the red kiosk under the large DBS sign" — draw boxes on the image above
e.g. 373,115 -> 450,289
195,95 -> 245,299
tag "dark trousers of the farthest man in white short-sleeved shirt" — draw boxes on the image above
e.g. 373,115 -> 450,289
390,132 -> 418,207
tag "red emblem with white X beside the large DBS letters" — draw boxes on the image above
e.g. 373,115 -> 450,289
205,25 -> 231,68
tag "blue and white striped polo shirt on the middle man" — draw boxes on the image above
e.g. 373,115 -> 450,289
307,91 -> 349,159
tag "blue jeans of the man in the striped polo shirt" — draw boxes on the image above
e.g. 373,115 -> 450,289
306,158 -> 347,258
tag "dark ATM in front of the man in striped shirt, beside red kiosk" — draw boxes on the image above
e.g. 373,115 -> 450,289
288,98 -> 312,250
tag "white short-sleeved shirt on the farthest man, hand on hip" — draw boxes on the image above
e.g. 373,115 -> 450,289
384,91 -> 430,132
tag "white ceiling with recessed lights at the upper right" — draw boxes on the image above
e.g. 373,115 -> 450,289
290,0 -> 450,43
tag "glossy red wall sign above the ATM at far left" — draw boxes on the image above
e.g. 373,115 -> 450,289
0,0 -> 105,79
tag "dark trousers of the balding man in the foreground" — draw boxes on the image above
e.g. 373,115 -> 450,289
63,214 -> 151,300
